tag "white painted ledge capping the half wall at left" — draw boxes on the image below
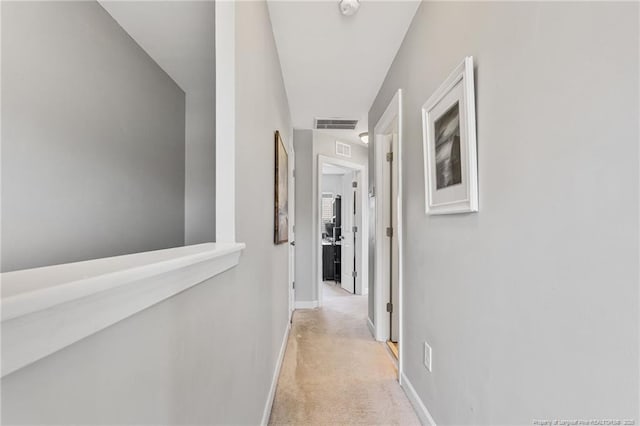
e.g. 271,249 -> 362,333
0,243 -> 245,377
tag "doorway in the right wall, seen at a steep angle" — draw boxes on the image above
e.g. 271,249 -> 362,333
372,90 -> 403,381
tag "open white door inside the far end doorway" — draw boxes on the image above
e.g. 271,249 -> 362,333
340,172 -> 355,293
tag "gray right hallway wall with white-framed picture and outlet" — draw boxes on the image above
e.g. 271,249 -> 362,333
369,2 -> 640,424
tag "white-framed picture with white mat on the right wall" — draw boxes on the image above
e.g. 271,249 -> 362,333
422,56 -> 478,215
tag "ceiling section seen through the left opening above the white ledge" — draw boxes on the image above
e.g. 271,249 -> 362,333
99,0 -> 215,95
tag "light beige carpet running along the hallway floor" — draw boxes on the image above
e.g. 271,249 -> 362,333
269,283 -> 420,425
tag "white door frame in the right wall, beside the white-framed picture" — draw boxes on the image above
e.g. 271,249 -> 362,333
372,89 -> 404,384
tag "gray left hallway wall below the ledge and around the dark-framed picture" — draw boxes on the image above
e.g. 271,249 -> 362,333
2,2 -> 290,425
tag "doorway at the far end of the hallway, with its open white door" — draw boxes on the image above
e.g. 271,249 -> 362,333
316,155 -> 368,306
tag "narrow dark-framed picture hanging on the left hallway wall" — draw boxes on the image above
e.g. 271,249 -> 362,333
273,130 -> 289,244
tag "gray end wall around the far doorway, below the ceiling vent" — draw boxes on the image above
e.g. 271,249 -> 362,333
293,130 -> 369,302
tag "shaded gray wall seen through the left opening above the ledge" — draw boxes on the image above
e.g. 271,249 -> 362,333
2,2 -> 185,271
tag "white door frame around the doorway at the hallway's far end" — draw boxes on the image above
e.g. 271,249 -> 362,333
312,154 -> 369,306
